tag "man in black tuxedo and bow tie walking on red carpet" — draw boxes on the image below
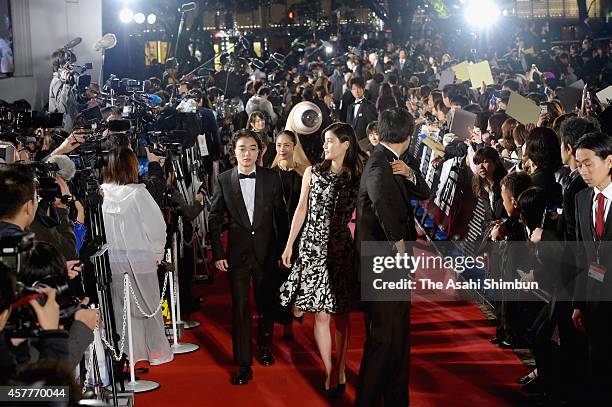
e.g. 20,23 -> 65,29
209,129 -> 289,384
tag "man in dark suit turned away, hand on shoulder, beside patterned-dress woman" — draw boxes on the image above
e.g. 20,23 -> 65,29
355,108 -> 429,406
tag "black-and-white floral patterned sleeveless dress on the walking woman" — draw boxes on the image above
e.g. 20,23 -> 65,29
280,166 -> 359,314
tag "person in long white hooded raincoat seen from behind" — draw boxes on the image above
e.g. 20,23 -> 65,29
101,148 -> 173,365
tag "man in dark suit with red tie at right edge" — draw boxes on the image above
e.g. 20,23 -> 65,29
572,132 -> 612,406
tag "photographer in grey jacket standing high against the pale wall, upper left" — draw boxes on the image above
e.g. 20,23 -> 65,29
49,49 -> 79,133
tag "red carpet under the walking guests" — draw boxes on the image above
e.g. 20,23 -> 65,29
136,275 -> 527,407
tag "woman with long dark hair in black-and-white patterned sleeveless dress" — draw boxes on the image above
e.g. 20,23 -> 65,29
280,123 -> 365,396
